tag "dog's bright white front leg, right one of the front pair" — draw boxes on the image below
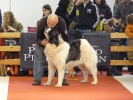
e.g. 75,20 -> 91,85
55,65 -> 65,87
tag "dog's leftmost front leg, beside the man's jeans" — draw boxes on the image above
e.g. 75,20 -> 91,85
43,66 -> 56,86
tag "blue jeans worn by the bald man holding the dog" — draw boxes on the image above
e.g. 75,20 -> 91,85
33,43 -> 65,81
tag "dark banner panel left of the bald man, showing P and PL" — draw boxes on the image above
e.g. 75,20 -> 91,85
20,33 -> 48,70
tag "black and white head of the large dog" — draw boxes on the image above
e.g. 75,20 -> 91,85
44,28 -> 59,46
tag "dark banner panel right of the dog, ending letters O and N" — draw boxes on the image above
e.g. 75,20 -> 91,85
83,33 -> 110,70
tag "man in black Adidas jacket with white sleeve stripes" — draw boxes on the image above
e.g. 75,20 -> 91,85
69,0 -> 100,33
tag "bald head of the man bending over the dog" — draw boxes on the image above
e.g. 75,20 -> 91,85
47,14 -> 58,28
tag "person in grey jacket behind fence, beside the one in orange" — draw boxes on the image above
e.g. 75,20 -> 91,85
113,0 -> 133,72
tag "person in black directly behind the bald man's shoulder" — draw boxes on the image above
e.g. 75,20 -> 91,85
55,0 -> 70,30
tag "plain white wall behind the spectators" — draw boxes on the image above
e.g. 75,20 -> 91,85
0,0 -> 115,32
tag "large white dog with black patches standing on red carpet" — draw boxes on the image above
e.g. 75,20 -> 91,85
44,28 -> 98,87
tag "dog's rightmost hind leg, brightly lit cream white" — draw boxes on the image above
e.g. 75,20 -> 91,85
87,63 -> 98,85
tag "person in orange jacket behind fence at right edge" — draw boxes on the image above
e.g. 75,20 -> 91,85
125,14 -> 133,75
